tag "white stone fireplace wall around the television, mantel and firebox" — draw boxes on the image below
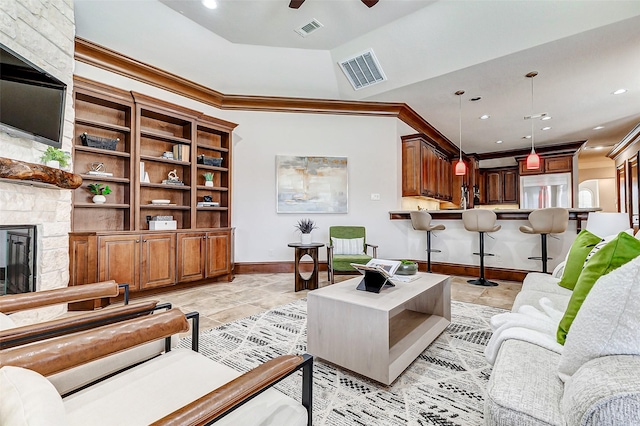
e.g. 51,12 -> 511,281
0,0 -> 75,319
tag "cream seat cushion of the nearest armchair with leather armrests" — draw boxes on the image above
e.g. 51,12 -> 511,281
63,349 -> 307,426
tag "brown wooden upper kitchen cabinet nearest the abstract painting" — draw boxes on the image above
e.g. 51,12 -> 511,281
402,135 -> 452,201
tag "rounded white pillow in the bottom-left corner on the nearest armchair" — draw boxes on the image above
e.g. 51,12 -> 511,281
0,366 -> 69,426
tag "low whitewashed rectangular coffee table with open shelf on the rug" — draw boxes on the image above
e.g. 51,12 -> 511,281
307,273 -> 451,385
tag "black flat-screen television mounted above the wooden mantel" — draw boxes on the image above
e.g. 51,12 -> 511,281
0,44 -> 67,148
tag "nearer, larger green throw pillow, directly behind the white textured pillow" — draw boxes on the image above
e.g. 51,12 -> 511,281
556,232 -> 640,345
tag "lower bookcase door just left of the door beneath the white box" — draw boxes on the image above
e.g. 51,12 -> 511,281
98,235 -> 140,291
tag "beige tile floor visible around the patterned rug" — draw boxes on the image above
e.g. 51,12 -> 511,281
133,273 -> 521,330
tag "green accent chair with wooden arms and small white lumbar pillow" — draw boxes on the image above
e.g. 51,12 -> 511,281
327,226 -> 378,284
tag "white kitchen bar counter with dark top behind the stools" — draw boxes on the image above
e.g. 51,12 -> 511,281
389,209 -> 600,271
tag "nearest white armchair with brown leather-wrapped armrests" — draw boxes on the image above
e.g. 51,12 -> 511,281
0,309 -> 313,426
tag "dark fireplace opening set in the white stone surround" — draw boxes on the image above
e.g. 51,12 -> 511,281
0,225 -> 37,294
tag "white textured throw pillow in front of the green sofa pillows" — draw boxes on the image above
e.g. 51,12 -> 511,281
558,256 -> 640,381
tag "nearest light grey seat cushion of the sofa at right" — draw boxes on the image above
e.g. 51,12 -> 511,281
485,340 -> 564,426
